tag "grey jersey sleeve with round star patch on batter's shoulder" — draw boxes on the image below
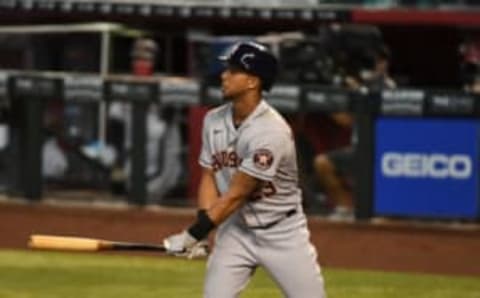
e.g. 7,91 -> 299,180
239,133 -> 290,181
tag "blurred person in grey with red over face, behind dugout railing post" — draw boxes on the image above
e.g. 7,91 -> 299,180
109,38 -> 182,203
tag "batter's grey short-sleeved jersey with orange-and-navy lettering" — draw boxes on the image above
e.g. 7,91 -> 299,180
199,100 -> 301,227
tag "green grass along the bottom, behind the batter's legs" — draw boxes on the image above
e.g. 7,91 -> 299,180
0,251 -> 480,298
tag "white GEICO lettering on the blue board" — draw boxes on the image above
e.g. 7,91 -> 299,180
382,152 -> 472,179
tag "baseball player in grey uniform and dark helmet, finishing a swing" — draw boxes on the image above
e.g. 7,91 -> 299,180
164,42 -> 326,298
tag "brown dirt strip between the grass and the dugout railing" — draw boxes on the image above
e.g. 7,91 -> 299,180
0,200 -> 480,275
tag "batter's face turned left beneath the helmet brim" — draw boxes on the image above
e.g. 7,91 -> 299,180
221,66 -> 257,99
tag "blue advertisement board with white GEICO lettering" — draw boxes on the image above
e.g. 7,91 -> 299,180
374,117 -> 480,219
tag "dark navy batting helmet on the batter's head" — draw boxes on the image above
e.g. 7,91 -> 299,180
218,41 -> 277,91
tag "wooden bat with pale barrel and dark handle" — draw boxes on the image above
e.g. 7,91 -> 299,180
28,234 -> 166,252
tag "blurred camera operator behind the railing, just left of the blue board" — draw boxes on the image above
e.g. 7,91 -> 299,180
314,46 -> 396,221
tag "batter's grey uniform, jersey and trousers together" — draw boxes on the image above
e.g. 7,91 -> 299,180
199,101 -> 325,298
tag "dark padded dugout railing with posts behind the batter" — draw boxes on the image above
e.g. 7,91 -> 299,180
0,71 -> 480,219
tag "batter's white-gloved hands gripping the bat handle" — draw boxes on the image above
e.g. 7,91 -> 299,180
163,231 -> 208,259
